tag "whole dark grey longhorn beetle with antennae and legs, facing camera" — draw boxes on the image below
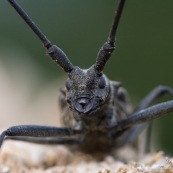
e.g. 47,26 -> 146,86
0,0 -> 173,152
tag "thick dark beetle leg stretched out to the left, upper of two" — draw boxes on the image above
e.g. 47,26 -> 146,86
0,125 -> 85,146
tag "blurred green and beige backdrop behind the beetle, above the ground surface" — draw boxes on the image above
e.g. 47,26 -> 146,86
0,0 -> 173,154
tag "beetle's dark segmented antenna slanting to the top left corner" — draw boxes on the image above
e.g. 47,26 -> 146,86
8,0 -> 73,73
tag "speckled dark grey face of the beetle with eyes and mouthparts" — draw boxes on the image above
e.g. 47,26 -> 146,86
66,66 -> 109,114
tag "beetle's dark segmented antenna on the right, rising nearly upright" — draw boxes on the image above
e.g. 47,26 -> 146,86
95,0 -> 125,72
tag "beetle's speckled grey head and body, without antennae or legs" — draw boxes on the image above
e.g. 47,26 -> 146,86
60,66 -> 132,152
